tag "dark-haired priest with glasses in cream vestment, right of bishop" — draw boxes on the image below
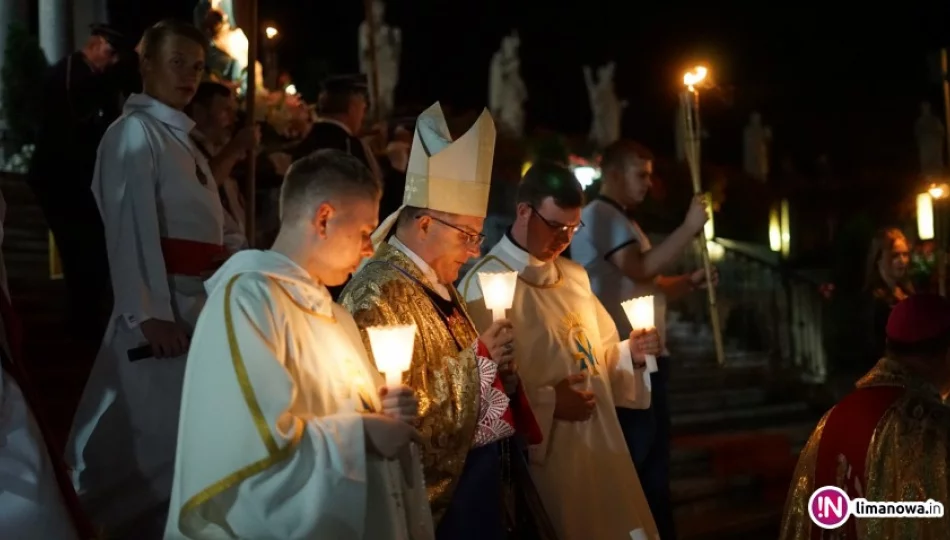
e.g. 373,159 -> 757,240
460,163 -> 665,540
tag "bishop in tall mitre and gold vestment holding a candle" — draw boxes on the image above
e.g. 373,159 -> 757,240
340,103 -> 552,540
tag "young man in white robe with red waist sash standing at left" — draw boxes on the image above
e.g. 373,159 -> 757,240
66,22 -> 237,540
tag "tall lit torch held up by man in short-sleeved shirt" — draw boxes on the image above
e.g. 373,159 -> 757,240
680,66 -> 726,366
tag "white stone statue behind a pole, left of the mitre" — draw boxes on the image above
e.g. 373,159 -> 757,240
359,0 -> 402,118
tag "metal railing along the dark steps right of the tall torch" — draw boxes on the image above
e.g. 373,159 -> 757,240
654,237 -> 828,383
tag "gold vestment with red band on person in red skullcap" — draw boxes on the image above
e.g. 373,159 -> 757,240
781,358 -> 950,540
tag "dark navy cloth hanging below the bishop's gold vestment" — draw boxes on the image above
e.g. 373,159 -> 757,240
435,442 -> 507,540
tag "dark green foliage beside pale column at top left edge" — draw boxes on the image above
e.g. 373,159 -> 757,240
0,24 -> 49,144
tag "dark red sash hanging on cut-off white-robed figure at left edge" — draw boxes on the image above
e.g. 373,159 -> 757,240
0,291 -> 97,540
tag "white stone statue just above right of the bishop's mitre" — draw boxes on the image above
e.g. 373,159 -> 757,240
488,32 -> 528,137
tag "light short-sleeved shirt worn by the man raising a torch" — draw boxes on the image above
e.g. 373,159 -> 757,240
571,197 -> 670,356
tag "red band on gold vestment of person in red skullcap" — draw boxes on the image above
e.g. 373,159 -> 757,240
811,386 -> 905,540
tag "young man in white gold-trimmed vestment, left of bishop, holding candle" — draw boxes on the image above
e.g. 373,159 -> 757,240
165,150 -> 434,540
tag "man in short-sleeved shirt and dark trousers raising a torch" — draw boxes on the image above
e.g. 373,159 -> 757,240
571,141 -> 716,538
